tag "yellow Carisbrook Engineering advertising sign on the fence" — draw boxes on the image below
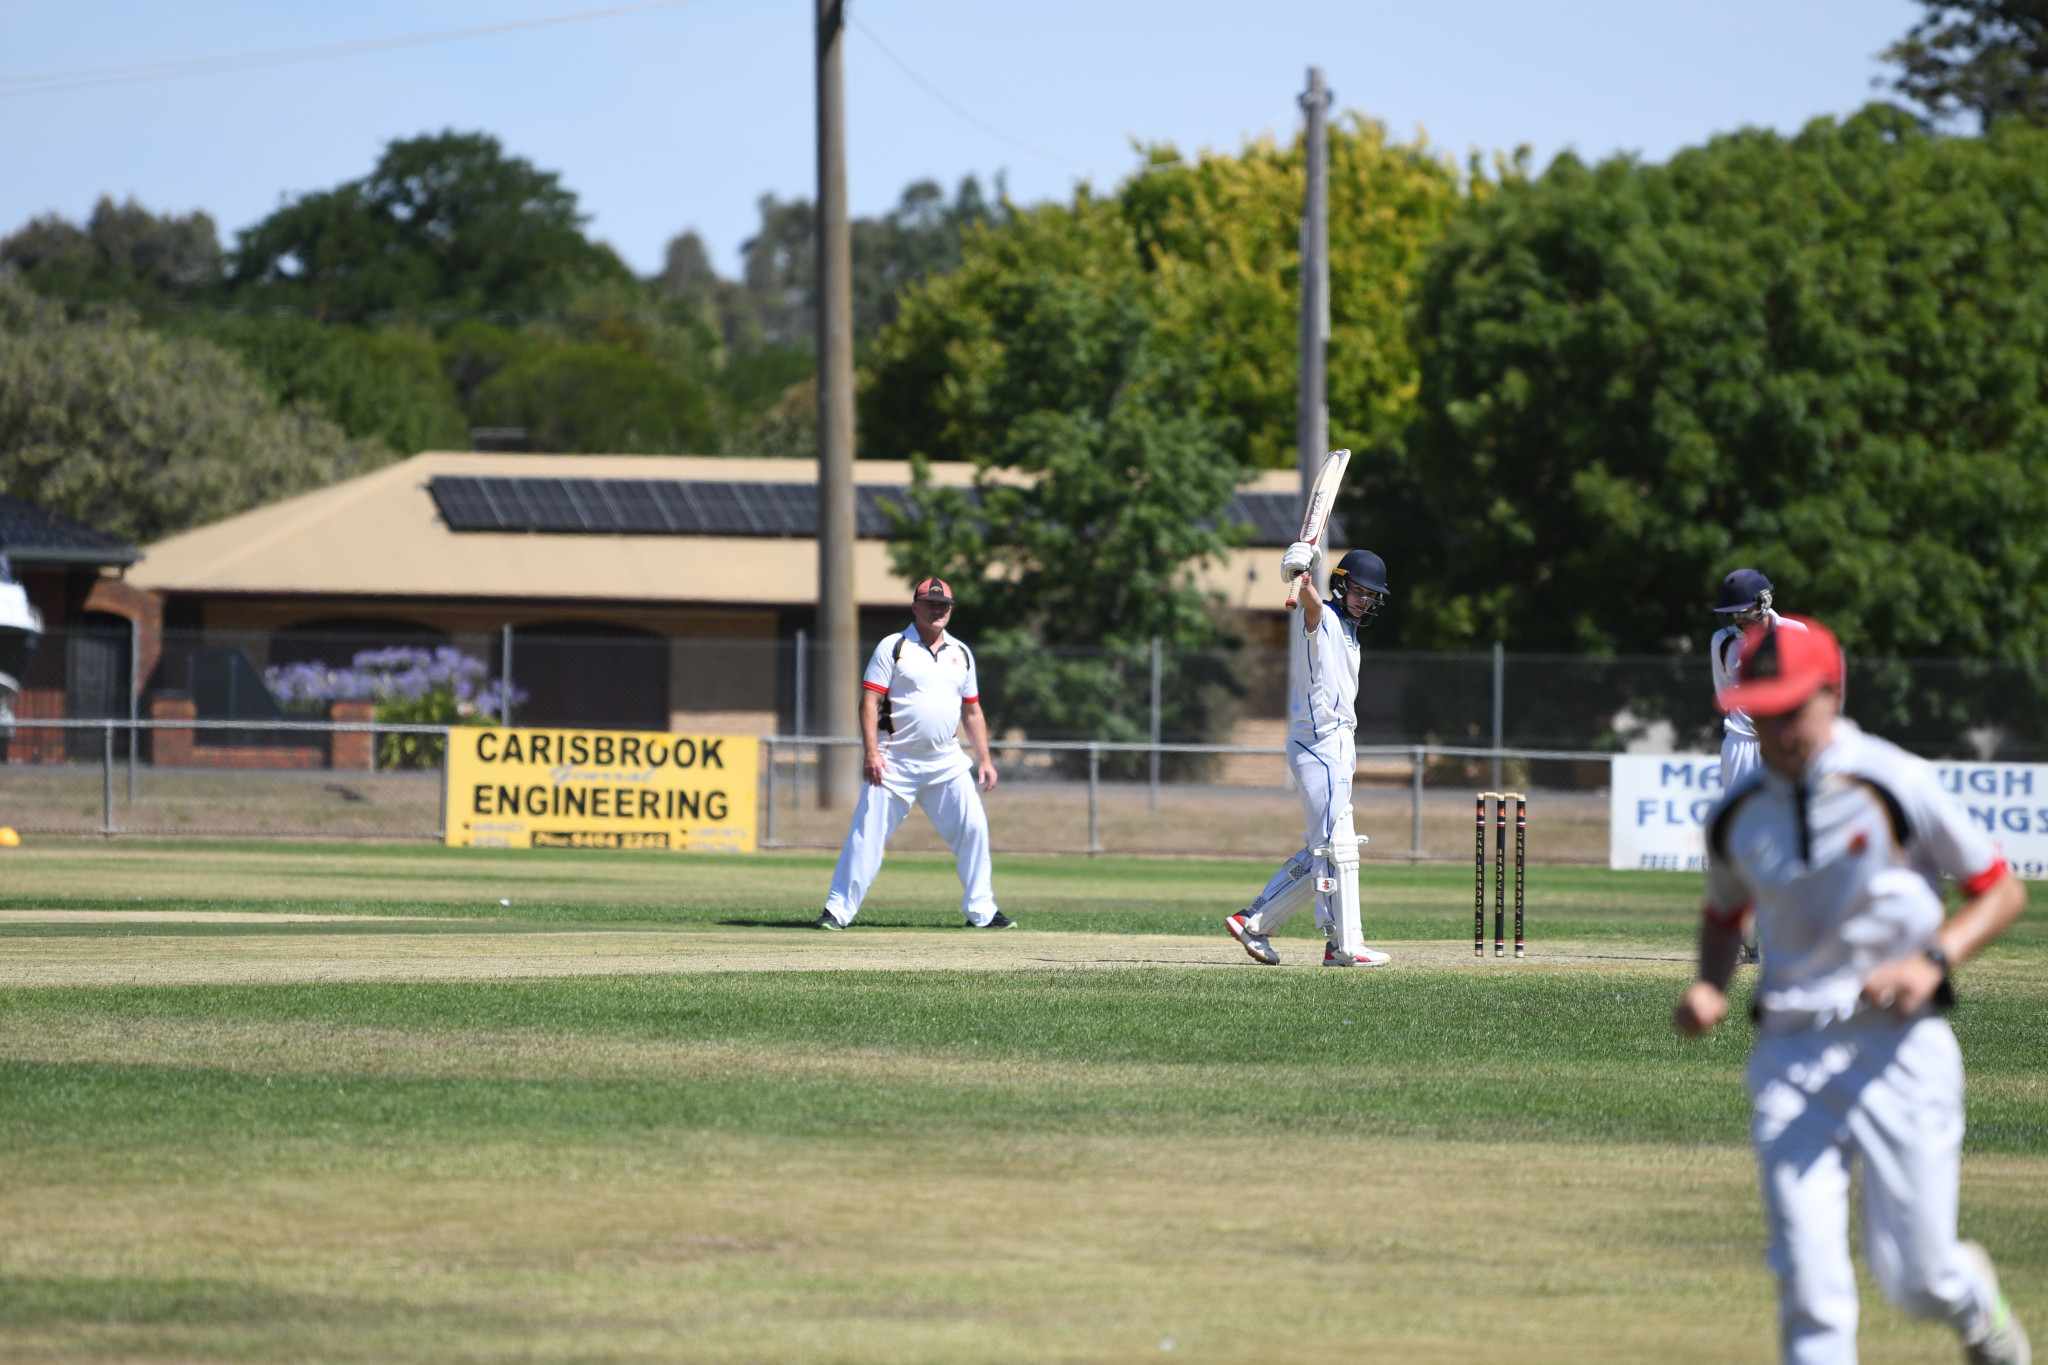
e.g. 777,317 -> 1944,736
446,726 -> 760,853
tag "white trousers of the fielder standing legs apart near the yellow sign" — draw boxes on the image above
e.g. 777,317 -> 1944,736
825,755 -> 995,927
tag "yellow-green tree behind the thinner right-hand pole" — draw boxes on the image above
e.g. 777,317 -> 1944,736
860,117 -> 1460,480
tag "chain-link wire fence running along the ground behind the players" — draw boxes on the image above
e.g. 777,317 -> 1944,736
0,620 -> 2048,862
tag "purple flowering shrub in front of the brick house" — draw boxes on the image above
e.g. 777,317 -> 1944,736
264,645 -> 526,767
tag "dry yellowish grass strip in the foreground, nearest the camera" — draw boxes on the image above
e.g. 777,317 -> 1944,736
0,1134 -> 2048,1365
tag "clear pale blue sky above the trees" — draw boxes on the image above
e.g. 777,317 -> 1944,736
0,0 -> 1919,272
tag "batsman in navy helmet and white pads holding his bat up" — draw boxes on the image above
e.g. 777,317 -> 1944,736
1223,540 -> 1389,966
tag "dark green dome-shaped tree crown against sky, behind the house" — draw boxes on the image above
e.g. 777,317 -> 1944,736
231,131 -> 631,317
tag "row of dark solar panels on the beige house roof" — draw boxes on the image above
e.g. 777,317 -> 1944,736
426,475 -> 1310,546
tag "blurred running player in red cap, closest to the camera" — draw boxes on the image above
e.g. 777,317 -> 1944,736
1673,618 -> 2030,1365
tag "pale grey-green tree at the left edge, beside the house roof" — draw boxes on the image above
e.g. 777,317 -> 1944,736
0,278 -> 391,540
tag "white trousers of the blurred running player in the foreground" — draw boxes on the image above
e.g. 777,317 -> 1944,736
1749,1011 -> 1993,1365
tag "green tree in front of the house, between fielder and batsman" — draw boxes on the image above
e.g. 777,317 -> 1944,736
879,196 -> 1241,739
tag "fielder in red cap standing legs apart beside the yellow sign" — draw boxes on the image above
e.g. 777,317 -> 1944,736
817,579 -> 1014,929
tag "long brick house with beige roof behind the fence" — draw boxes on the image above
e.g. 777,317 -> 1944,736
129,452 -> 1300,733
